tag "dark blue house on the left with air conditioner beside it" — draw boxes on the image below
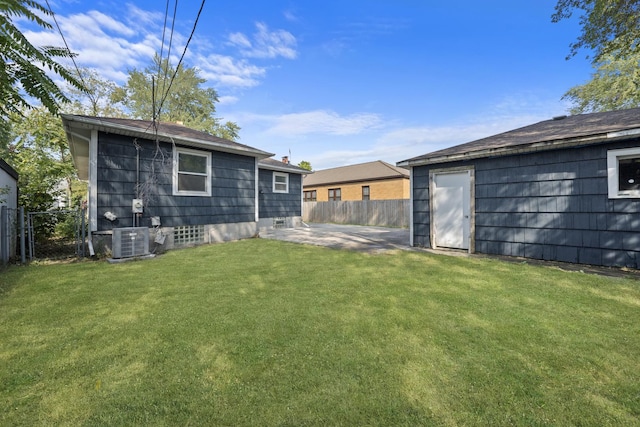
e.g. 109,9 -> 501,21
62,115 -> 306,252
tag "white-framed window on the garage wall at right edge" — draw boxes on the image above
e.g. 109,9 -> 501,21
607,147 -> 640,199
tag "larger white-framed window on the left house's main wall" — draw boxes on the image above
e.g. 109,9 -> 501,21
173,148 -> 211,196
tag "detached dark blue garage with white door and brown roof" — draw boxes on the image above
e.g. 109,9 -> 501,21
397,109 -> 640,268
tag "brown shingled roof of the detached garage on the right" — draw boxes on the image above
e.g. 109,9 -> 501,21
397,108 -> 640,166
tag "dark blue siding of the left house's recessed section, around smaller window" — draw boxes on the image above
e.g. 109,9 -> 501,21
258,169 -> 302,218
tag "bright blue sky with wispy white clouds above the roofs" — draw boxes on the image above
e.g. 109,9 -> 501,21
23,0 -> 592,170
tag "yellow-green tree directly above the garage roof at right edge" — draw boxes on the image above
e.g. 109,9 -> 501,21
562,54 -> 640,114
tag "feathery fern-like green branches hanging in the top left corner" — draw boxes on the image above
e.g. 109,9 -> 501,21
0,0 -> 83,119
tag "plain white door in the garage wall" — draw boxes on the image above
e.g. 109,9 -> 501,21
432,171 -> 471,249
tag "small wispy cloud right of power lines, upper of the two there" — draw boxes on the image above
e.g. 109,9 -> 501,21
228,22 -> 298,59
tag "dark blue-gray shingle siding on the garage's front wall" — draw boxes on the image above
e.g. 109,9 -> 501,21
414,141 -> 640,268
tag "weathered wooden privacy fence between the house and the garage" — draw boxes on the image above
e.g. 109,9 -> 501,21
302,199 -> 410,228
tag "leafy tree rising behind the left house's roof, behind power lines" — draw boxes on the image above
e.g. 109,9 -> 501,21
111,56 -> 240,140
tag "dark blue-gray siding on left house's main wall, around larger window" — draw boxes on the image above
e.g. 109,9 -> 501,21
97,133 -> 255,231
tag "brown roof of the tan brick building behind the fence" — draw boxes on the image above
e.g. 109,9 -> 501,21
304,160 -> 409,187
